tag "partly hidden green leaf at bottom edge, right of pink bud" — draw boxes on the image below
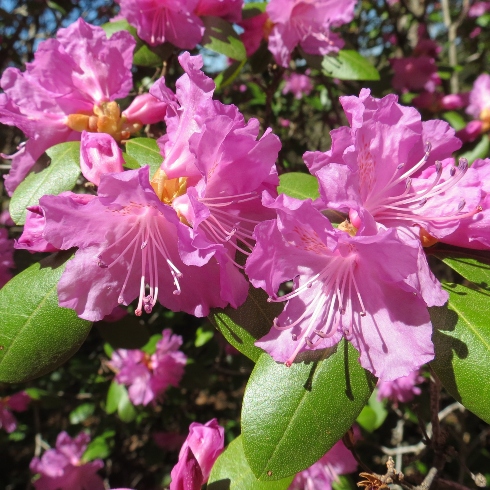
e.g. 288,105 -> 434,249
207,436 -> 294,490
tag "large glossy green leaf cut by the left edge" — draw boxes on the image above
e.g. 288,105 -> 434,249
0,252 -> 92,383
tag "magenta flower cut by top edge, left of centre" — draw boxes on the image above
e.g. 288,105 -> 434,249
117,0 -> 204,49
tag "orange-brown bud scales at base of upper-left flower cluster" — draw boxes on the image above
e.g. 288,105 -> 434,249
66,101 -> 143,142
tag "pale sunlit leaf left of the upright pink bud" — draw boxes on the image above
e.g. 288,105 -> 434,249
9,141 -> 80,225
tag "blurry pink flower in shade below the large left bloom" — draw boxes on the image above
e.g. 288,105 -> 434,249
108,329 -> 187,405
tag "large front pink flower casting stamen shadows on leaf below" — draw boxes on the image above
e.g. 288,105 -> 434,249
246,195 -> 434,380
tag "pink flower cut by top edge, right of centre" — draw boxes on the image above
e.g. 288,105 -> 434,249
267,0 -> 356,68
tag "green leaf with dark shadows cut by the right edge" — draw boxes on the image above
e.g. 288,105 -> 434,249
430,282 -> 490,423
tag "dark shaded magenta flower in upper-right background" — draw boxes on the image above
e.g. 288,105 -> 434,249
390,55 -> 441,92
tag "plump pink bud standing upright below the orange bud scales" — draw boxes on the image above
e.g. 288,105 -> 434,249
80,131 -> 124,185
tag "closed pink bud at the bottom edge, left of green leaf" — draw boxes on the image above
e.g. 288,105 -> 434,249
170,419 -> 225,490
